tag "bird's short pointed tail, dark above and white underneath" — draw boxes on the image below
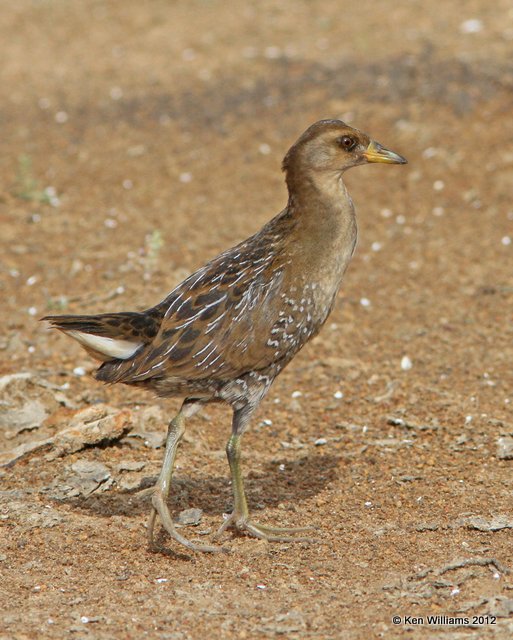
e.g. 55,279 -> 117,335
41,310 -> 160,362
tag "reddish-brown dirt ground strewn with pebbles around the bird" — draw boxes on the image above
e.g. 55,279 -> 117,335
0,0 -> 513,640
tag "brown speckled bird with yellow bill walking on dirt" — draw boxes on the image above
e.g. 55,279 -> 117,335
42,119 -> 407,552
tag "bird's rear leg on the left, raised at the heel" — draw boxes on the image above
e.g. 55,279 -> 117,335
148,400 -> 224,552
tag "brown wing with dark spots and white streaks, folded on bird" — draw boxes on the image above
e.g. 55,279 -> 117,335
99,229 -> 283,383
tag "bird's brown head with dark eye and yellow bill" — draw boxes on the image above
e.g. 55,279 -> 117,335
283,120 -> 407,182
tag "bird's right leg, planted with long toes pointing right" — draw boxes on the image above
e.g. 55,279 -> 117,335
214,407 -> 314,542
